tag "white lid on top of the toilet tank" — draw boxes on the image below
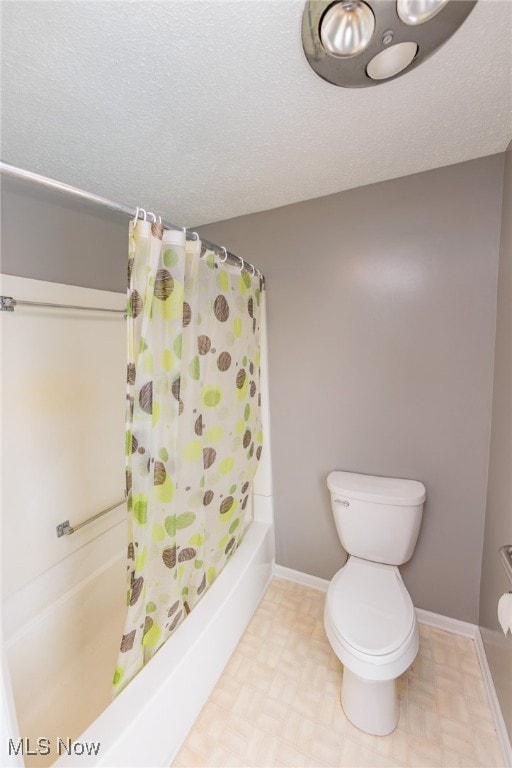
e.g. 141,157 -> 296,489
327,472 -> 426,507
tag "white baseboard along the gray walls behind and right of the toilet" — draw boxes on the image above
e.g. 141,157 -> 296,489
274,564 -> 512,768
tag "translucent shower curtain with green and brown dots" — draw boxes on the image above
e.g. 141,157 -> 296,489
114,221 -> 263,693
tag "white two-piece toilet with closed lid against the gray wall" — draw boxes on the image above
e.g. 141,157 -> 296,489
324,472 -> 425,736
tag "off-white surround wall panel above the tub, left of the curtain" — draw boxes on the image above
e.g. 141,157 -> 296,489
0,275 -> 126,608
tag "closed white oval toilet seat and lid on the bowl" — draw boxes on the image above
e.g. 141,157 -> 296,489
325,557 -> 418,680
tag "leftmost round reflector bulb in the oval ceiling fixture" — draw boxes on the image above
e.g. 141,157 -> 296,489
320,0 -> 375,58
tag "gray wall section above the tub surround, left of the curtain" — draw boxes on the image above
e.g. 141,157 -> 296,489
0,176 -> 128,291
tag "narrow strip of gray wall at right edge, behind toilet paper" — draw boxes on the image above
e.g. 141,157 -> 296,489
480,144 -> 512,741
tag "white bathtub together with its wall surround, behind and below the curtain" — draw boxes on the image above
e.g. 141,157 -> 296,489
1,275 -> 275,768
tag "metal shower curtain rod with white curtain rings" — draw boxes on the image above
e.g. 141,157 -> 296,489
0,161 -> 265,282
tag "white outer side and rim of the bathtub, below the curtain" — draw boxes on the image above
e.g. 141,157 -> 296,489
61,520 -> 274,768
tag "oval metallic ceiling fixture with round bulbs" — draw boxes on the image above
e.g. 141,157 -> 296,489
302,0 -> 477,88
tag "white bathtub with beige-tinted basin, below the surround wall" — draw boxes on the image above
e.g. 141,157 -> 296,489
5,508 -> 274,768
